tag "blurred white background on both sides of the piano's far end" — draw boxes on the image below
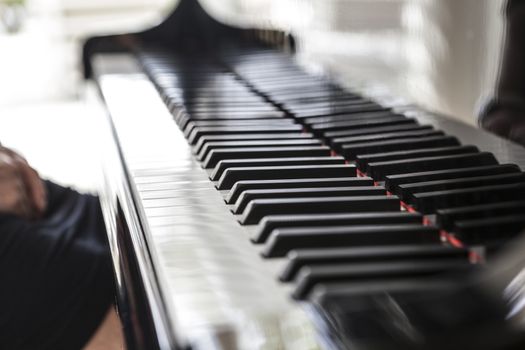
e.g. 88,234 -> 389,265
0,0 -> 504,191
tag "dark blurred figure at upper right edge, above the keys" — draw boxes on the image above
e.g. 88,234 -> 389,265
479,0 -> 525,146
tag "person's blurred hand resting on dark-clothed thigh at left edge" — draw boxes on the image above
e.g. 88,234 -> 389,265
0,147 -> 46,219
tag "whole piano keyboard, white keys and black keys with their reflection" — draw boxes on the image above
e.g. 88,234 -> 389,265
95,45 -> 525,349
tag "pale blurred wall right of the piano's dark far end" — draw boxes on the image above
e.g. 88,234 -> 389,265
205,0 -> 504,123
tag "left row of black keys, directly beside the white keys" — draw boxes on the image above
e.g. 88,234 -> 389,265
138,48 -> 512,298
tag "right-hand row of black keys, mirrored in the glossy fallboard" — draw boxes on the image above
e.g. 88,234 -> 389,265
227,52 -> 525,242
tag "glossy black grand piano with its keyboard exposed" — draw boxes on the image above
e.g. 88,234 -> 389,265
83,0 -> 525,349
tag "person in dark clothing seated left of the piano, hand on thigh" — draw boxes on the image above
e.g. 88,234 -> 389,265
0,146 -> 122,350
